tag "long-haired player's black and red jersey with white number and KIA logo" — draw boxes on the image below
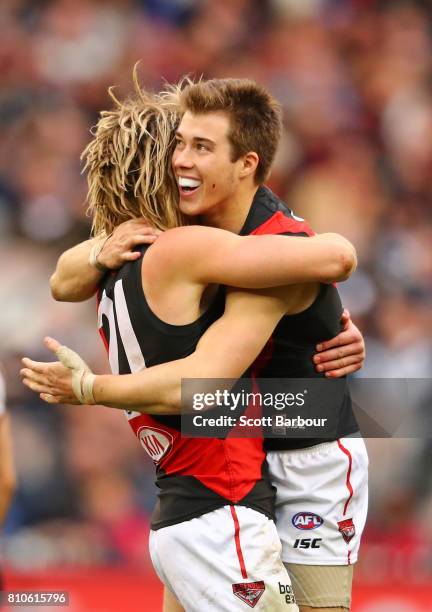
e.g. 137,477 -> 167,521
98,247 -> 274,529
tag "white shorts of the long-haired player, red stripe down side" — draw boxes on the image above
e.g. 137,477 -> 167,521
150,506 -> 298,612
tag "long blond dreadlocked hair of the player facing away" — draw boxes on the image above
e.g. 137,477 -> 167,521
81,67 -> 187,235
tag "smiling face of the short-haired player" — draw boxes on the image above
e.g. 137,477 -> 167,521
172,111 -> 243,216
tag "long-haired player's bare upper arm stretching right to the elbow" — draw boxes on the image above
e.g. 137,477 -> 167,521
147,225 -> 357,289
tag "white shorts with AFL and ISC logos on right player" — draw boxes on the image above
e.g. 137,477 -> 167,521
267,437 -> 369,565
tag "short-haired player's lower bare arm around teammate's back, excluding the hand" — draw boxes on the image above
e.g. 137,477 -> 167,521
93,288 -> 298,414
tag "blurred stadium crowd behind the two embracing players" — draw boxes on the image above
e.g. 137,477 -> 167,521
0,0 -> 432,612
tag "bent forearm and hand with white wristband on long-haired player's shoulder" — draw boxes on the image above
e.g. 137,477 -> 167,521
50,219 -> 160,302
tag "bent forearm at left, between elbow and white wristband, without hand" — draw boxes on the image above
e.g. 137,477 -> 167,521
50,238 -> 102,302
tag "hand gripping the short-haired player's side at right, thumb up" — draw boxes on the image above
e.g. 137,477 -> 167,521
313,309 -> 366,378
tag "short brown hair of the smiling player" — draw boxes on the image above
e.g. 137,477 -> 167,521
180,79 -> 282,184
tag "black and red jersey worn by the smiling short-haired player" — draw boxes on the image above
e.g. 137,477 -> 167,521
240,187 -> 358,450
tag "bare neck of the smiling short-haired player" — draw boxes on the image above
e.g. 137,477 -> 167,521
201,185 -> 258,234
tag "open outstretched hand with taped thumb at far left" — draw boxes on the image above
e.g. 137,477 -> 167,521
20,337 -> 94,404
